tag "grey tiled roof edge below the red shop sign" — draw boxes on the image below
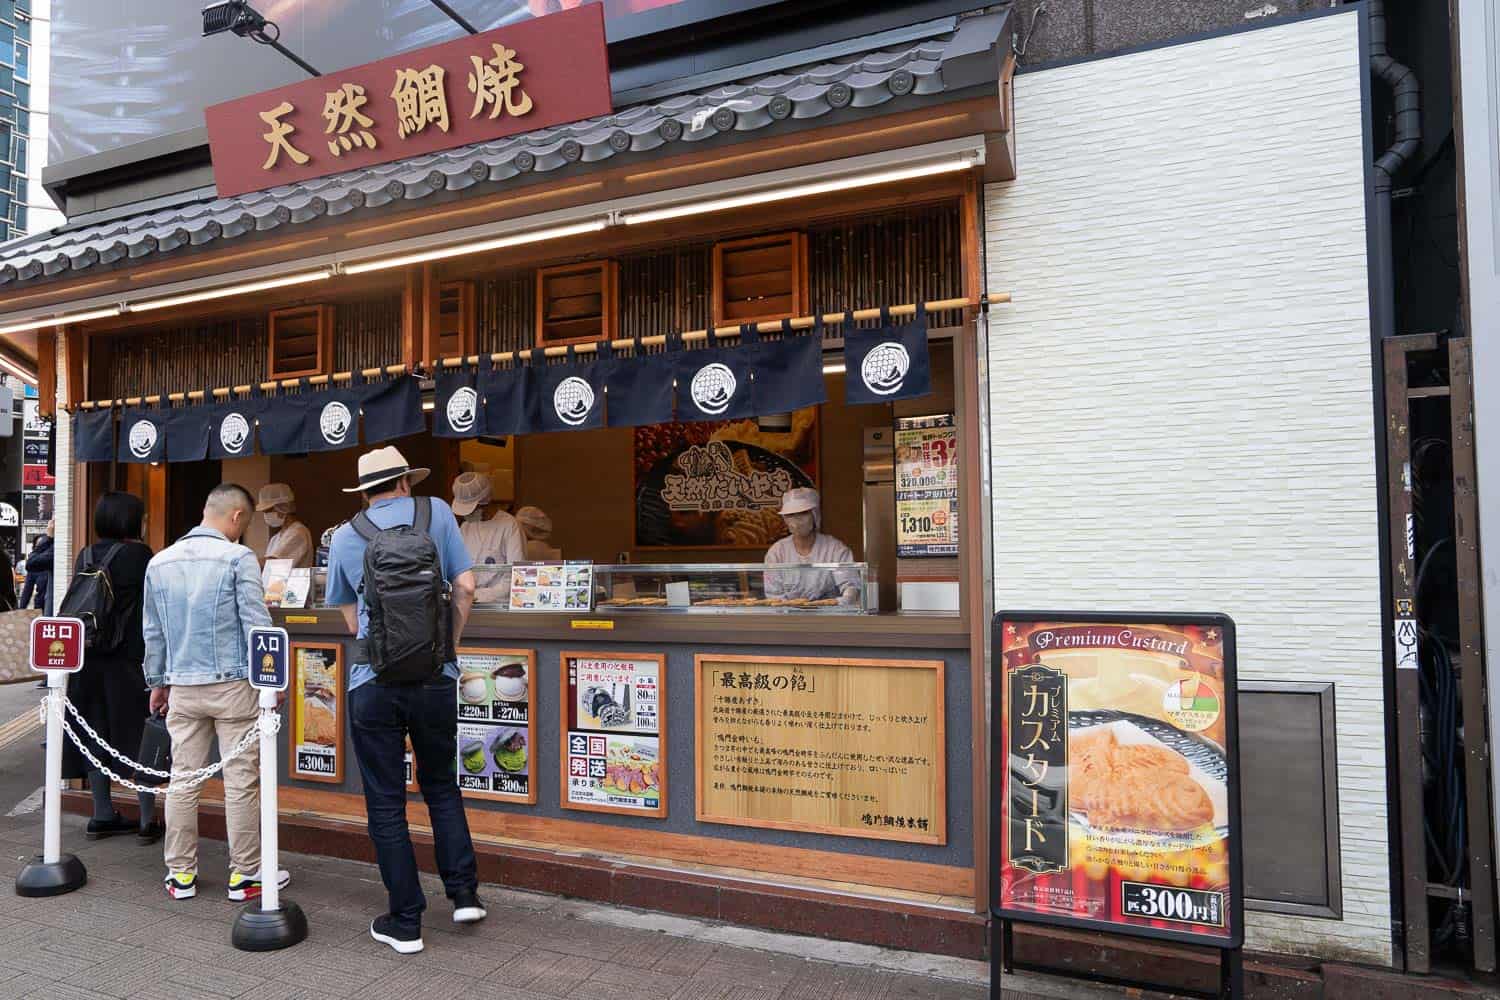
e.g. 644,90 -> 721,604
0,18 -> 998,289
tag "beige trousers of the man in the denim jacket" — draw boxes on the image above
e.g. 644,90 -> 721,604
167,681 -> 261,876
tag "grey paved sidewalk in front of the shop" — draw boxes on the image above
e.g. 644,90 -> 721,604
0,803 -> 1095,1000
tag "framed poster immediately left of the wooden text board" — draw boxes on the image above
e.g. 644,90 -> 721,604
560,652 -> 666,819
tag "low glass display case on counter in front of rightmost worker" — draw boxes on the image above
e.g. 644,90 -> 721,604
594,562 -> 869,615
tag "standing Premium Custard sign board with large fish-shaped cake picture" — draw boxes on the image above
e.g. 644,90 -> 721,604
992,613 -> 1244,948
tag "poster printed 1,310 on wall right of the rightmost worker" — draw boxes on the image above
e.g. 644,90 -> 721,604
896,414 -> 959,559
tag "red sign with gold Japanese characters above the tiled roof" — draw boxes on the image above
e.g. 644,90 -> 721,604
204,3 -> 612,198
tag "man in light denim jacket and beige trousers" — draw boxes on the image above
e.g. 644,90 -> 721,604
144,483 -> 291,901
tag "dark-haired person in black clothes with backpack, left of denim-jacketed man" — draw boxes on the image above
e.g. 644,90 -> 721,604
63,492 -> 162,844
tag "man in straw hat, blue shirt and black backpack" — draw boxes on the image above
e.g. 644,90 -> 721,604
329,447 -> 486,955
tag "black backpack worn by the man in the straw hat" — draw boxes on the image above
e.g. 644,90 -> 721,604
354,496 -> 456,684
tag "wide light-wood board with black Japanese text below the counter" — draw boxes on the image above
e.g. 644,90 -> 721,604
693,655 -> 948,844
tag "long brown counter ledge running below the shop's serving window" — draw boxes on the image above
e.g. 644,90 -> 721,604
272,609 -> 969,649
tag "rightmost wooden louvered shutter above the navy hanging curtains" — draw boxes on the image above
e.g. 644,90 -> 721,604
714,232 -> 807,325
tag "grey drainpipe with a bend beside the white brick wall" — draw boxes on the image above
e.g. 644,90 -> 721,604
1367,0 -> 1422,337
